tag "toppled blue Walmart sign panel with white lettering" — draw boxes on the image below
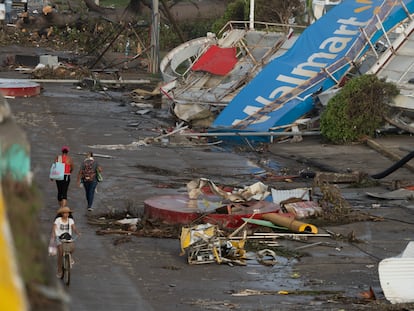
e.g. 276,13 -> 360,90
212,0 -> 414,131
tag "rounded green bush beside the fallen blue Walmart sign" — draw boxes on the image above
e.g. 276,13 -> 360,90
320,75 -> 399,144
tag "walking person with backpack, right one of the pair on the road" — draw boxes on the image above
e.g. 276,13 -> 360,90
77,152 -> 102,212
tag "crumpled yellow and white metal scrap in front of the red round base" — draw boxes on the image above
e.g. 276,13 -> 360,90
180,223 -> 246,265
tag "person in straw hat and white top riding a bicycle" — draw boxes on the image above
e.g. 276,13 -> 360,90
52,206 -> 81,278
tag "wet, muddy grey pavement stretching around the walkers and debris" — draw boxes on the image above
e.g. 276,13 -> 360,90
1,44 -> 414,311
